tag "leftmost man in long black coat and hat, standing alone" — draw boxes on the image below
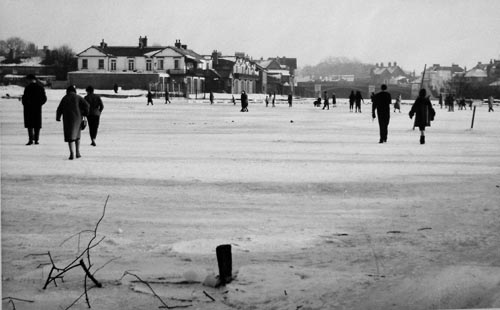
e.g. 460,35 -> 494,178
22,74 -> 47,145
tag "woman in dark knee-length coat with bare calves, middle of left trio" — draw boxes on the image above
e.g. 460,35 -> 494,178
56,86 -> 89,160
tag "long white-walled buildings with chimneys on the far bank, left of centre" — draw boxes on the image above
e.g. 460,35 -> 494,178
68,36 -> 297,95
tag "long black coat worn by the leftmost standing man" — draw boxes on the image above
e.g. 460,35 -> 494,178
22,83 -> 47,128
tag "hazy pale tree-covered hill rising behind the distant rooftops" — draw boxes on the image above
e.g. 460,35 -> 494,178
297,57 -> 374,79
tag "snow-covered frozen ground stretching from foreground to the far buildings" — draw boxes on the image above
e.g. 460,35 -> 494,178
0,86 -> 500,309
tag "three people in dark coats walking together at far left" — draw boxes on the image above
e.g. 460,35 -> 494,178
21,74 -> 104,160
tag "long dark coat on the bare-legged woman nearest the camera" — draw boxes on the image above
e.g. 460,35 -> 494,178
56,92 -> 89,142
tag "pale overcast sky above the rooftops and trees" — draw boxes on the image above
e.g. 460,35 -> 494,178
0,0 -> 500,72
